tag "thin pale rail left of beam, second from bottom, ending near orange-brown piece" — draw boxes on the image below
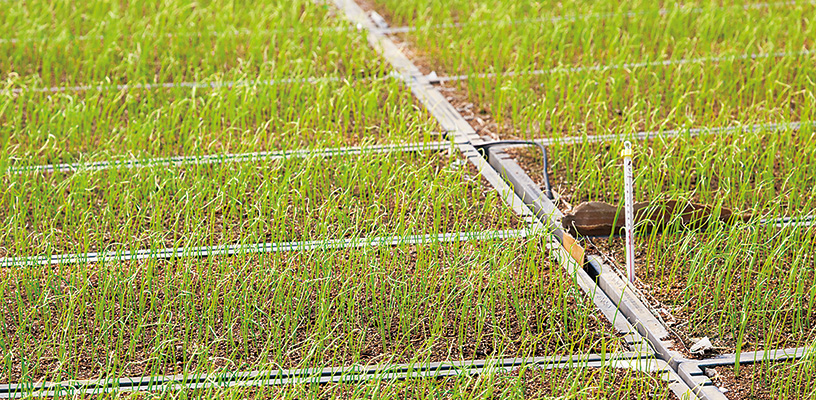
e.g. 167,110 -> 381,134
0,226 -> 538,268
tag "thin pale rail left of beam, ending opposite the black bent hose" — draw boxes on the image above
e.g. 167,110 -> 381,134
8,141 -> 452,174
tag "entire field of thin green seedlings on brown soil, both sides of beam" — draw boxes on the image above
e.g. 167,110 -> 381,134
0,0 -> 816,400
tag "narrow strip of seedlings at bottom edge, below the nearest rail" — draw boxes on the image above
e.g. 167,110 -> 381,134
25,368 -> 677,400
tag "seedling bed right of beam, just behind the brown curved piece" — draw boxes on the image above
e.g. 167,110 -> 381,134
505,124 -> 816,219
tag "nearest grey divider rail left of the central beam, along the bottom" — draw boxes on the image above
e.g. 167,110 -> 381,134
0,353 -> 652,398
